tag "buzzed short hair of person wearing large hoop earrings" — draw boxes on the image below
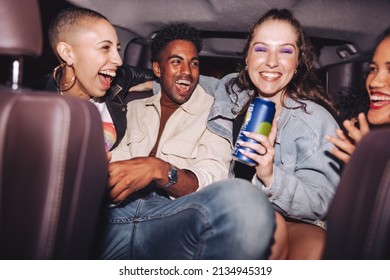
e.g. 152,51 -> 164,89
49,7 -> 109,54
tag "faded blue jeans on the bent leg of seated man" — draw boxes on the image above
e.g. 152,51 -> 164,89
98,179 -> 275,259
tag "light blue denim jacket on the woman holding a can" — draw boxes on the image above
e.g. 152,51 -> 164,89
154,73 -> 340,227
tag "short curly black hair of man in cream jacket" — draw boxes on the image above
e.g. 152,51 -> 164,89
150,23 -> 202,62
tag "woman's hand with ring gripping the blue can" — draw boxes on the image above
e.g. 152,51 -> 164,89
238,118 -> 278,187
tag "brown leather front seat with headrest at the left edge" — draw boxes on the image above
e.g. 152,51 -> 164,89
0,0 -> 107,260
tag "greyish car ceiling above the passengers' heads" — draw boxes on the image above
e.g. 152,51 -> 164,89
68,0 -> 390,64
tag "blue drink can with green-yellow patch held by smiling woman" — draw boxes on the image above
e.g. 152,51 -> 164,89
233,97 -> 275,166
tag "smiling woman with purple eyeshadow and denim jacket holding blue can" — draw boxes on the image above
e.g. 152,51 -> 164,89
200,9 -> 340,259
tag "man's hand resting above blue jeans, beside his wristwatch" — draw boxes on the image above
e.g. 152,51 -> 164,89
108,157 -> 168,202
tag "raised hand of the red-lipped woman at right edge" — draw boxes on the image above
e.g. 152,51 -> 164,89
327,113 -> 370,163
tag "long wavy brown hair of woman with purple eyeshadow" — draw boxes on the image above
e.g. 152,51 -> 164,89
226,9 -> 336,116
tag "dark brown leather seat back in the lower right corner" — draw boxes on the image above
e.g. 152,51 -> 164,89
324,128 -> 390,260
